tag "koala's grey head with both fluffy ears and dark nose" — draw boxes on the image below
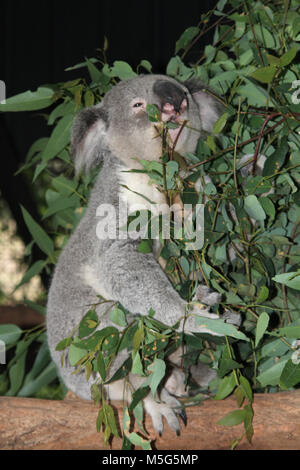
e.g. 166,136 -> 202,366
71,75 -> 220,172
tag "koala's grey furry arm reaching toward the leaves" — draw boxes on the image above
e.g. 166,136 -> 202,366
98,241 -> 187,325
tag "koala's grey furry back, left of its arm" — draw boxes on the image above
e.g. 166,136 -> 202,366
47,158 -> 122,365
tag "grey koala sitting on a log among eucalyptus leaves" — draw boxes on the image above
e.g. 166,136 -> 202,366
47,74 -> 234,434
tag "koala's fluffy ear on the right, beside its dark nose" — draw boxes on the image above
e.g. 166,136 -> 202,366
184,79 -> 224,132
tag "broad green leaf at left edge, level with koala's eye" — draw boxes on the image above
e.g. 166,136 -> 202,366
0,87 -> 54,112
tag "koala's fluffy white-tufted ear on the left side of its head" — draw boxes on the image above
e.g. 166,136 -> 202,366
71,105 -> 108,174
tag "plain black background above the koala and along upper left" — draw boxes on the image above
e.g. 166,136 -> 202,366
0,0 -> 216,266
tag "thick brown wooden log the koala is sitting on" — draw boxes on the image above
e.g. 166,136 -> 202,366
0,390 -> 300,450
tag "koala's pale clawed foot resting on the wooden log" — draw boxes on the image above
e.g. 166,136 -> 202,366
144,388 -> 186,436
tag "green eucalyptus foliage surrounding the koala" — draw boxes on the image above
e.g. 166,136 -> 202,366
0,0 -> 300,448
